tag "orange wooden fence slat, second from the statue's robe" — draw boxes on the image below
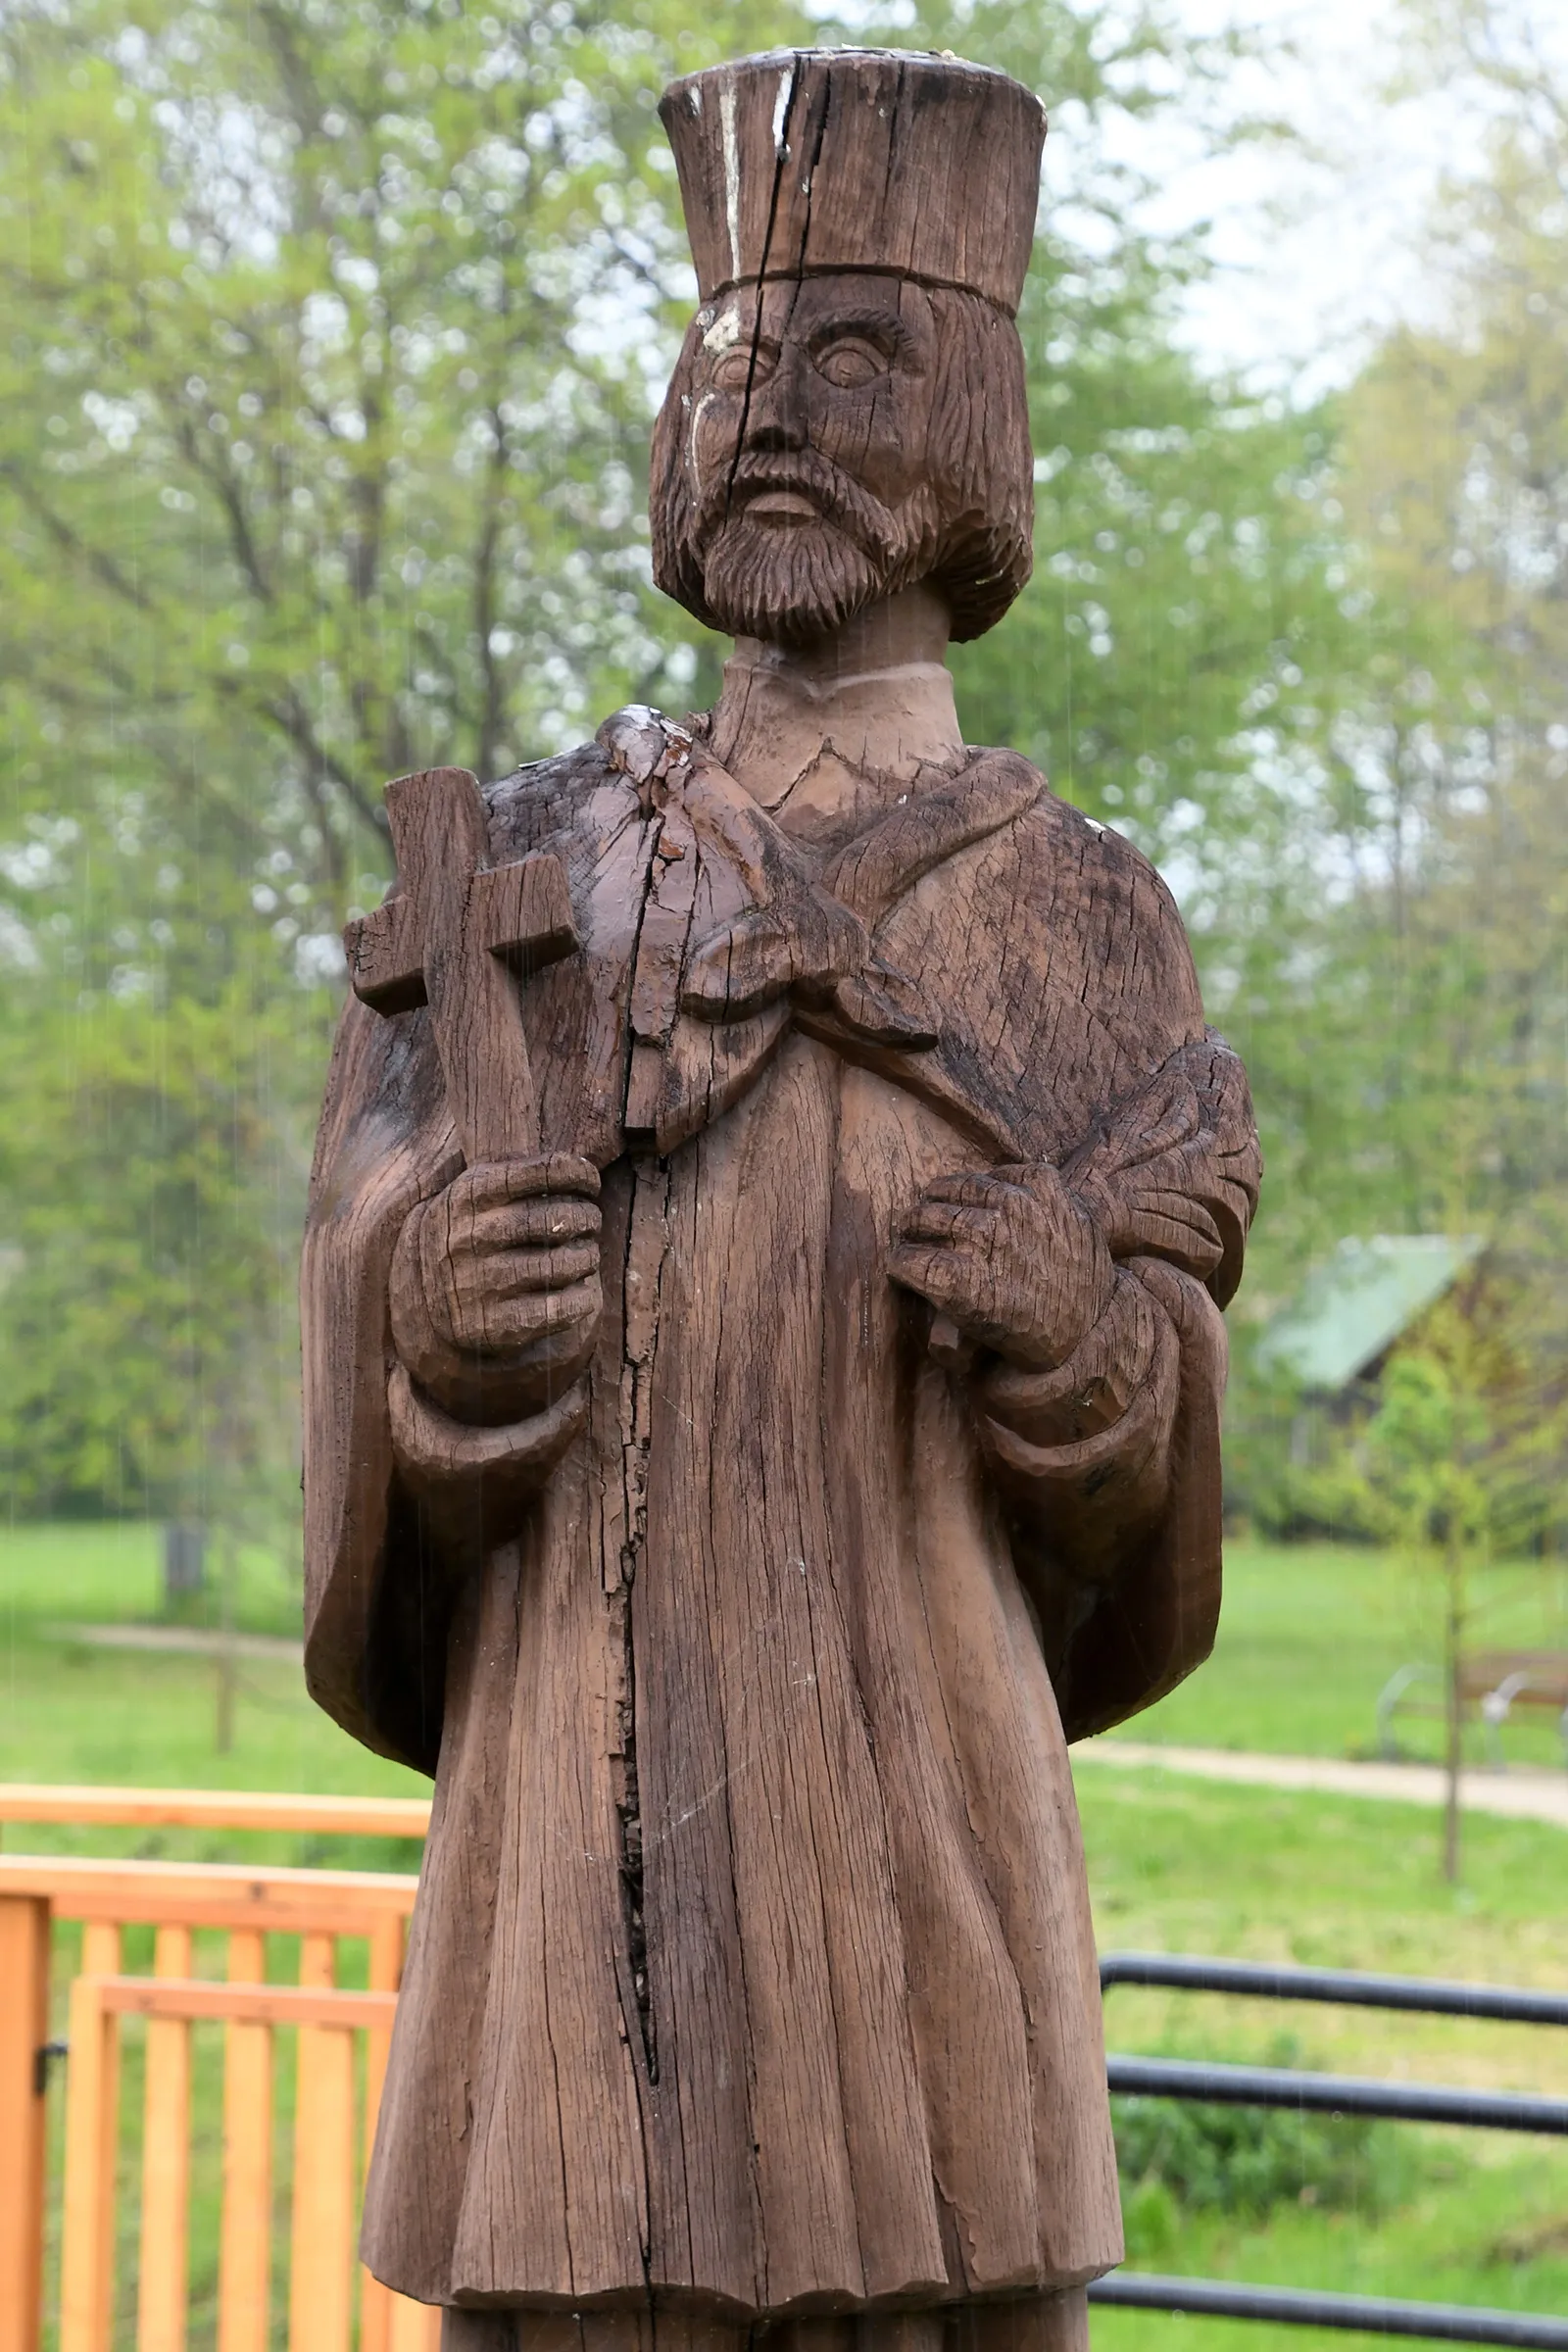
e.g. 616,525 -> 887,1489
289,1936 -> 358,2352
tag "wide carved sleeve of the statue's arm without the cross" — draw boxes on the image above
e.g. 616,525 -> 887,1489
992,1035 -> 1260,1739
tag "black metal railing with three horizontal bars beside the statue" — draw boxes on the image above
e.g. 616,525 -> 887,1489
1089,1952 -> 1568,2352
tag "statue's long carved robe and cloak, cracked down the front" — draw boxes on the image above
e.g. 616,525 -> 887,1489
303,712 -> 1257,2319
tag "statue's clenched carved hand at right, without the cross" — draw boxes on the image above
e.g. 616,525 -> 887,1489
889,1162 -> 1116,1371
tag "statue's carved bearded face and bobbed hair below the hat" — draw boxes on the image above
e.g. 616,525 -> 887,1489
649,270 -> 1034,645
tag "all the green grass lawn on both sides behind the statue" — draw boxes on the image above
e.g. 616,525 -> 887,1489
0,1529 -> 1568,2352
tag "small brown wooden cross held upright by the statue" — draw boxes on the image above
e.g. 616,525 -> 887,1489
343,766 -> 578,1166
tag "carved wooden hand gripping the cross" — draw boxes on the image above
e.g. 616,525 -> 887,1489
393,1152 -> 602,1423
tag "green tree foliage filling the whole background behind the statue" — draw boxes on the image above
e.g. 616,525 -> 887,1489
0,0 -> 1568,1524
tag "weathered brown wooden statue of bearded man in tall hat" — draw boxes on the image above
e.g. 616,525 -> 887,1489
303,49 -> 1257,2352
